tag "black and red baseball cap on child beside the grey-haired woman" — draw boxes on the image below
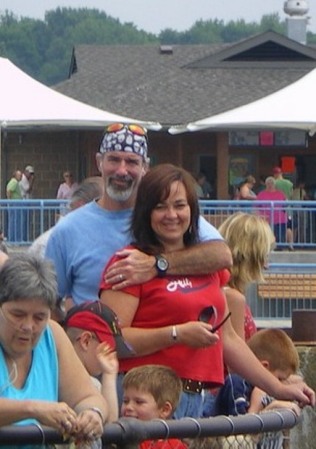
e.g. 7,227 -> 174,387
63,301 -> 135,358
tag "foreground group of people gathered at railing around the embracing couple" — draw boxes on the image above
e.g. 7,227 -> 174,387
0,124 -> 315,449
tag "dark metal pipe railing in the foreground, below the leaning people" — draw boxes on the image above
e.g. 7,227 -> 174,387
0,409 -> 300,449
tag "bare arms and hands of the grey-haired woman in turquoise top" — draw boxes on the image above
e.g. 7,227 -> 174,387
0,321 -> 108,435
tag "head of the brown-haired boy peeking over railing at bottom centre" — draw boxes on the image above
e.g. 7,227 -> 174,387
122,365 -> 182,421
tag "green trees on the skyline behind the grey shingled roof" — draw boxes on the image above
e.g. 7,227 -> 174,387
0,7 -> 316,85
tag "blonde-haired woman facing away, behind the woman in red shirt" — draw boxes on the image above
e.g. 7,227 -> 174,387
219,212 -> 275,340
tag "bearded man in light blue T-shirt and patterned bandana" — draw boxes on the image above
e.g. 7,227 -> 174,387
45,123 -> 231,308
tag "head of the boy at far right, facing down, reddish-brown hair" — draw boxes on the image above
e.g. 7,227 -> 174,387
247,329 -> 299,380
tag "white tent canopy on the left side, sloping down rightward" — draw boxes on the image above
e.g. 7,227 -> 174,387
0,58 -> 161,129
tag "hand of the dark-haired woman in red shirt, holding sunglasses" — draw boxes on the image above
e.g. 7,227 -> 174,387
177,321 -> 219,348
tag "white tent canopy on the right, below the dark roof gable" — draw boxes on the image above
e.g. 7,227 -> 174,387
169,69 -> 316,135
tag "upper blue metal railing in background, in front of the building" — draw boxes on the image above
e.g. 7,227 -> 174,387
0,200 -> 316,249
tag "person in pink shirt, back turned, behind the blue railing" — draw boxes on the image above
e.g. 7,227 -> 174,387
257,176 -> 287,247
